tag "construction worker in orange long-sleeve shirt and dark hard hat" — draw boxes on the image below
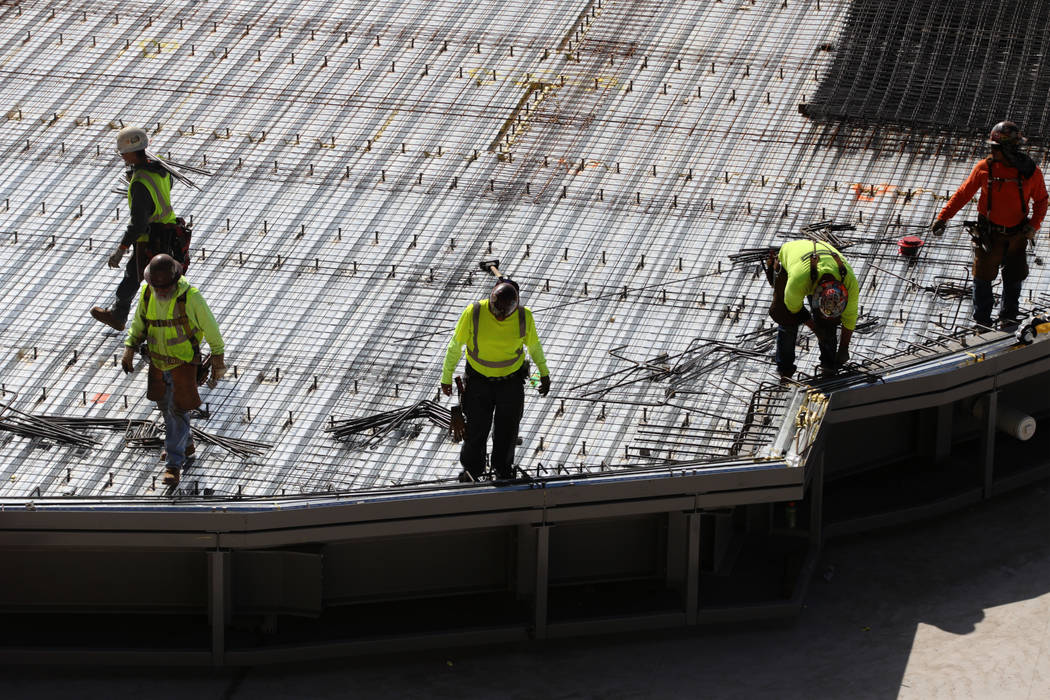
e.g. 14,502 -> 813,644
930,122 -> 1047,326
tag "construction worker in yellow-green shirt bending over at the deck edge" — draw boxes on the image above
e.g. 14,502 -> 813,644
767,239 -> 860,379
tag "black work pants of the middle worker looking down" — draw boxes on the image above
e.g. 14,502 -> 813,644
460,365 -> 525,479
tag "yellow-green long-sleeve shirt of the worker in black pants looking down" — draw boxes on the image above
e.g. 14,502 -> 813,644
441,299 -> 550,384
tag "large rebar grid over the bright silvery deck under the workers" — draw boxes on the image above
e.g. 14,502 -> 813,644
0,0 -> 1043,499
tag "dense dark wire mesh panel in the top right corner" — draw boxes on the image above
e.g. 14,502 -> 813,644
804,0 -> 1050,137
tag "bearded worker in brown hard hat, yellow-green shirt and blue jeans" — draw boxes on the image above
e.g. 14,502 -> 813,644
121,254 -> 226,486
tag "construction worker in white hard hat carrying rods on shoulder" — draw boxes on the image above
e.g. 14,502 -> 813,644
91,126 -> 176,331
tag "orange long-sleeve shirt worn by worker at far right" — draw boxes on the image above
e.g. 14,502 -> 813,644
937,158 -> 1047,229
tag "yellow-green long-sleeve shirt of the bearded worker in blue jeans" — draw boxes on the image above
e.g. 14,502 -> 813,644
124,277 -> 226,369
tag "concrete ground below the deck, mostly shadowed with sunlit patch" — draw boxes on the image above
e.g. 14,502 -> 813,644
0,482 -> 1050,700
